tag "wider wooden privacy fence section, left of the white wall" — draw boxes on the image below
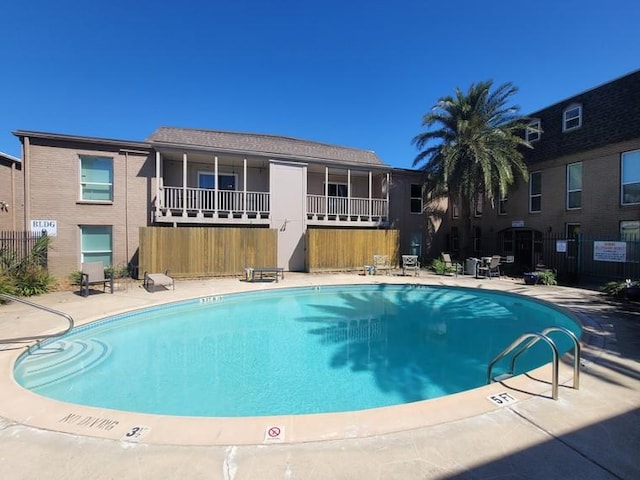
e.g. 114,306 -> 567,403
138,227 -> 278,277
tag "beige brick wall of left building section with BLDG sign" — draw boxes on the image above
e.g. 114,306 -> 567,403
27,144 -> 155,277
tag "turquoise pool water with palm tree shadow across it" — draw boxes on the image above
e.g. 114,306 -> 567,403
14,285 -> 580,417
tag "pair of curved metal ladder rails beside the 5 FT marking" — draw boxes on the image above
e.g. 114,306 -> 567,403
487,327 -> 580,400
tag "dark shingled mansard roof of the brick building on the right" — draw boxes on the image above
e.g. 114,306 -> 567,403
523,70 -> 640,163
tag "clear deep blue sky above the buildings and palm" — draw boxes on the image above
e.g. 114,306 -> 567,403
0,0 -> 640,168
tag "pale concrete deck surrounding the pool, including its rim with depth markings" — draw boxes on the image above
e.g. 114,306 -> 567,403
0,272 -> 640,480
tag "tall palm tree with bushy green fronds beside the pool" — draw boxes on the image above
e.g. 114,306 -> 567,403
412,80 -> 531,257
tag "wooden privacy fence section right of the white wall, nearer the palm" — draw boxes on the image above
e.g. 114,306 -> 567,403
306,228 -> 400,272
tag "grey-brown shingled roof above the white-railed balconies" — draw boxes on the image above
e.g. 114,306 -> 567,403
146,127 -> 387,167
